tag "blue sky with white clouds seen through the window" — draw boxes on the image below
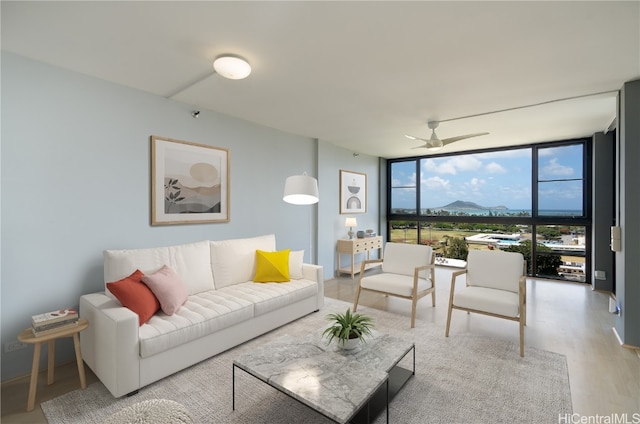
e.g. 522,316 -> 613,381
391,144 -> 583,210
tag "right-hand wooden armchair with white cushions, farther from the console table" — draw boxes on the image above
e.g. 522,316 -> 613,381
445,250 -> 527,356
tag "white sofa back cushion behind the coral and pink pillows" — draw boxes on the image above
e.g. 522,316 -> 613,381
104,240 -> 214,294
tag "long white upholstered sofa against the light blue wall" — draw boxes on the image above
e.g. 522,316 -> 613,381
80,235 -> 324,397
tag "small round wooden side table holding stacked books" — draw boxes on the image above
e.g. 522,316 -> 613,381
18,318 -> 89,411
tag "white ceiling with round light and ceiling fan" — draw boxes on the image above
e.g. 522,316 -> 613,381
1,1 -> 640,158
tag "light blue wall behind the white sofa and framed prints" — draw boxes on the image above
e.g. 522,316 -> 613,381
0,52 -> 377,381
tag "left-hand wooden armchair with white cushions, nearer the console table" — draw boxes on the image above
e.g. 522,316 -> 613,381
353,242 -> 436,328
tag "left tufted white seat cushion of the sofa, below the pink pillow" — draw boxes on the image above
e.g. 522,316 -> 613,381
139,283 -> 254,358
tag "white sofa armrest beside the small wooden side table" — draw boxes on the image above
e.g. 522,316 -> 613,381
79,292 -> 140,397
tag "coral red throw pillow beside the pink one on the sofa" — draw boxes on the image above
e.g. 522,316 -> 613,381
107,269 -> 160,325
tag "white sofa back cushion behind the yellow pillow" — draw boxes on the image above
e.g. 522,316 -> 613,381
210,234 -> 276,289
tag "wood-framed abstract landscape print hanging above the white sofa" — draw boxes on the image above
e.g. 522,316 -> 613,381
151,136 -> 230,225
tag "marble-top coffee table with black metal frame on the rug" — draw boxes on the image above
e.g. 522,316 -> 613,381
233,332 -> 415,423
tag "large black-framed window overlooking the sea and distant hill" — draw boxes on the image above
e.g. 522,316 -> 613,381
387,139 -> 591,282
